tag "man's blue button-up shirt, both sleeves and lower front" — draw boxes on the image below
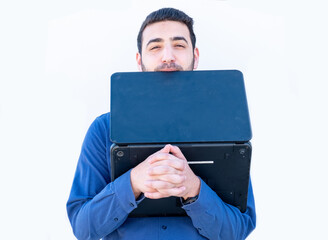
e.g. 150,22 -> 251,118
67,113 -> 256,240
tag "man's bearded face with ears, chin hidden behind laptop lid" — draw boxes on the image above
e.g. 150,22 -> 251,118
137,21 -> 199,71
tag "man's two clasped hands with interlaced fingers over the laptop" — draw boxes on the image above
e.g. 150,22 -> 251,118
131,144 -> 200,199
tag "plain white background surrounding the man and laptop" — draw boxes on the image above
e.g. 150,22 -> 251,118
0,0 -> 328,240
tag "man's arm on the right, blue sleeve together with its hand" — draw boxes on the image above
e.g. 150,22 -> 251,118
145,145 -> 256,240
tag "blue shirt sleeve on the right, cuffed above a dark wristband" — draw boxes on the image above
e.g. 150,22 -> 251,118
183,180 -> 256,240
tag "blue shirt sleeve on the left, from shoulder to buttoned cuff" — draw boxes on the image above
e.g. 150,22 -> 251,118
67,117 -> 137,239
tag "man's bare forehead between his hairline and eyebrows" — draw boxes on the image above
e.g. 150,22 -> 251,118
142,21 -> 190,45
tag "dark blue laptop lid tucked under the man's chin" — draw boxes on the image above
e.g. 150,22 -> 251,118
110,70 -> 252,144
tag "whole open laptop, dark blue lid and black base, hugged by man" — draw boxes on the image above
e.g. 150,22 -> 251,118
110,70 -> 252,217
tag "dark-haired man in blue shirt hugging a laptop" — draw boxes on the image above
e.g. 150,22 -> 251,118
67,8 -> 255,240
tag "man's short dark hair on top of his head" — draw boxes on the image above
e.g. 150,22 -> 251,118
137,8 -> 196,54
